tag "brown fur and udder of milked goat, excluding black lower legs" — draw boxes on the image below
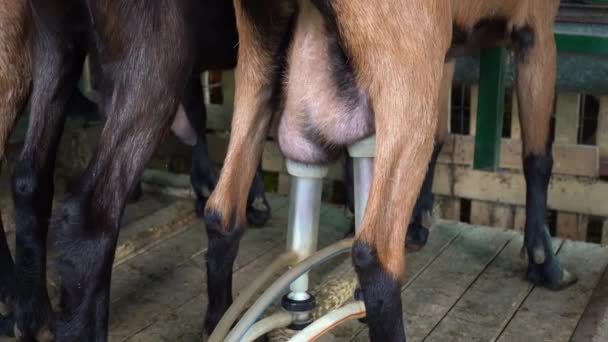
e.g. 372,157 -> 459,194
210,0 -> 559,277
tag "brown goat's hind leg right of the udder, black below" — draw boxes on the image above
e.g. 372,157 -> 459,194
326,0 -> 451,342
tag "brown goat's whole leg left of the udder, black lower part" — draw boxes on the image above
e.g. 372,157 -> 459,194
204,0 -> 295,334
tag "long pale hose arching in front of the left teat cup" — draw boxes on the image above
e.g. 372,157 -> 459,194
225,239 -> 353,342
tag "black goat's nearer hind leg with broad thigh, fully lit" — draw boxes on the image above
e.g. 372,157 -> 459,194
53,0 -> 193,341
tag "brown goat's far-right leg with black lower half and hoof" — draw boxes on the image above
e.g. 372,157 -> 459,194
515,16 -> 577,290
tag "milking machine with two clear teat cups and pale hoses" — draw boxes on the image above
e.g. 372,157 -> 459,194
209,136 -> 375,342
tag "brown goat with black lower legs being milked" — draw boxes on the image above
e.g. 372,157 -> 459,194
206,0 -> 576,341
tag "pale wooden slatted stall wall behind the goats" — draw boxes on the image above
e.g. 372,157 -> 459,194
197,71 -> 608,244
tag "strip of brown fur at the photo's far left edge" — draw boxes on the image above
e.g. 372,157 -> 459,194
0,0 -> 32,160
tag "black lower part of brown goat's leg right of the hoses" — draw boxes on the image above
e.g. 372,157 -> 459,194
352,241 -> 405,342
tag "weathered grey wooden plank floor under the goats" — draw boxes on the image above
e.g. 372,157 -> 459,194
0,194 -> 608,342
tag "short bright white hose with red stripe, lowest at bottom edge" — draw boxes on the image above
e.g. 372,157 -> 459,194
289,301 -> 365,342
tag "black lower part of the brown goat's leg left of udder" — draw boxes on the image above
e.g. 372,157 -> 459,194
204,210 -> 245,335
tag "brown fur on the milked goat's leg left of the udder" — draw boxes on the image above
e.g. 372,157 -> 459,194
207,1 -> 295,230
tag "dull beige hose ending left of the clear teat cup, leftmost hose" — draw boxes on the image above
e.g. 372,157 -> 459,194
209,252 -> 298,342
